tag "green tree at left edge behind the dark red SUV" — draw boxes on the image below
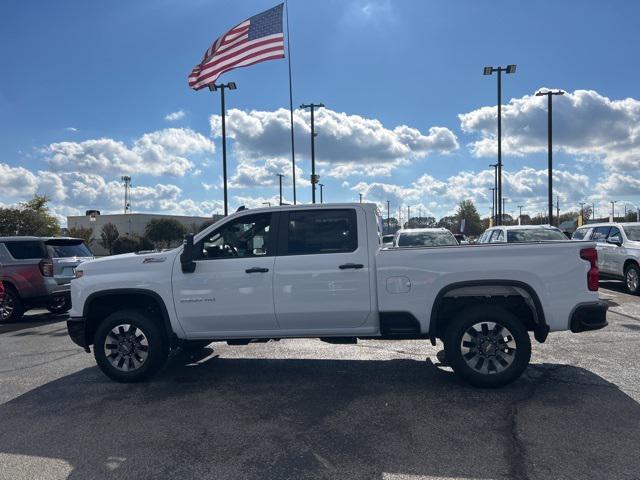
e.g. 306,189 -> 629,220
0,195 -> 60,237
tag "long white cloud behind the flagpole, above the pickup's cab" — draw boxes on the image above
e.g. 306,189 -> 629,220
210,108 -> 459,177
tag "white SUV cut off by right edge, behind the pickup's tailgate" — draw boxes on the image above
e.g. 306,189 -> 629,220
572,222 -> 640,295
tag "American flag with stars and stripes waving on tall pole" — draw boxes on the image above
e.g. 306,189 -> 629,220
189,3 -> 284,90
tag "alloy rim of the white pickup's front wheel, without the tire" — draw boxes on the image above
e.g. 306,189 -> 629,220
104,323 -> 149,372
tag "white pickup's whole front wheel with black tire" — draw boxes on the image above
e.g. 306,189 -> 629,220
93,309 -> 169,383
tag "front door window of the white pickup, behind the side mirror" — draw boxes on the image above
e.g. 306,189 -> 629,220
198,213 -> 272,259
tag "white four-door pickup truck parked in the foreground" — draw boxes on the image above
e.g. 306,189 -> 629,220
68,204 -> 607,387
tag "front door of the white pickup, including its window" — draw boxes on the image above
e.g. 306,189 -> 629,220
173,213 -> 278,338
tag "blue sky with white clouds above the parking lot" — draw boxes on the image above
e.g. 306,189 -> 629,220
0,0 -> 640,223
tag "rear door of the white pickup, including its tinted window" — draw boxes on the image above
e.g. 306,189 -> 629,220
274,208 -> 375,332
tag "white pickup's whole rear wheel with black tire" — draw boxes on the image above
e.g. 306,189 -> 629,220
444,305 -> 531,388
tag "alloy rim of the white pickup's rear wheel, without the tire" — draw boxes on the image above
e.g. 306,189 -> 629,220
460,322 -> 516,375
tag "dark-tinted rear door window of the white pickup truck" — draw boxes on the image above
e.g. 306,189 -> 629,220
287,209 -> 358,255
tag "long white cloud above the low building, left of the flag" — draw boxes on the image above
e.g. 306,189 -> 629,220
44,128 -> 215,176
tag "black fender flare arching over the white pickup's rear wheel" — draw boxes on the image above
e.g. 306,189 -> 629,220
429,280 -> 549,345
